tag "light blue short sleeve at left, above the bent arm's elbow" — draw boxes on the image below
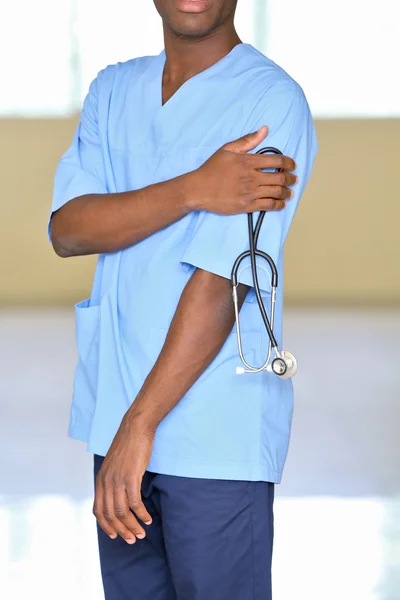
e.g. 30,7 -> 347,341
49,74 -> 107,236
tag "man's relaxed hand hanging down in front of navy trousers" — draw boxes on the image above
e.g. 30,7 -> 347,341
93,411 -> 154,544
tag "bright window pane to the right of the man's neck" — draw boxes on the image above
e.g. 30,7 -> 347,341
257,0 -> 400,118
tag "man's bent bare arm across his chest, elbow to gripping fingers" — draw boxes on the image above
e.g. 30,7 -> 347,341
51,127 -> 297,257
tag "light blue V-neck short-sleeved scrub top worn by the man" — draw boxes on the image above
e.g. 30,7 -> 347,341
52,44 -> 317,483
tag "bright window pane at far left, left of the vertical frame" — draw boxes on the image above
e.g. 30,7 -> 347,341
0,0 -> 74,117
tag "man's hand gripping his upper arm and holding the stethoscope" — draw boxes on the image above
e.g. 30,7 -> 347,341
187,126 -> 298,215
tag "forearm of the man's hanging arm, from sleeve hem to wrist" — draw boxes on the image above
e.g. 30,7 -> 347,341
127,269 -> 249,429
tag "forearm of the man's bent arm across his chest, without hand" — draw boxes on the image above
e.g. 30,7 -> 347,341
51,175 -> 196,257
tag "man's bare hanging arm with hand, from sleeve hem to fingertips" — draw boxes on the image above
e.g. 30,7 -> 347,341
94,269 -> 248,543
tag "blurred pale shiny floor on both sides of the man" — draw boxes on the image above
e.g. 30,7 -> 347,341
0,310 -> 400,600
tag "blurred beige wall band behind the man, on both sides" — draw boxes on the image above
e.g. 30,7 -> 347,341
0,119 -> 400,305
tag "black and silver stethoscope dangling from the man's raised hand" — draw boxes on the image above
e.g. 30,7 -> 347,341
231,148 -> 297,379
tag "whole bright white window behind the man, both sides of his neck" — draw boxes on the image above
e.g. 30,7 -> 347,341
0,0 -> 400,118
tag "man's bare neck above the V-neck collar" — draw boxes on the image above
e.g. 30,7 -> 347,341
164,23 -> 241,84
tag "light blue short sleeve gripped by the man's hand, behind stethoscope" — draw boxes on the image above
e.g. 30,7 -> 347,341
181,80 -> 317,292
